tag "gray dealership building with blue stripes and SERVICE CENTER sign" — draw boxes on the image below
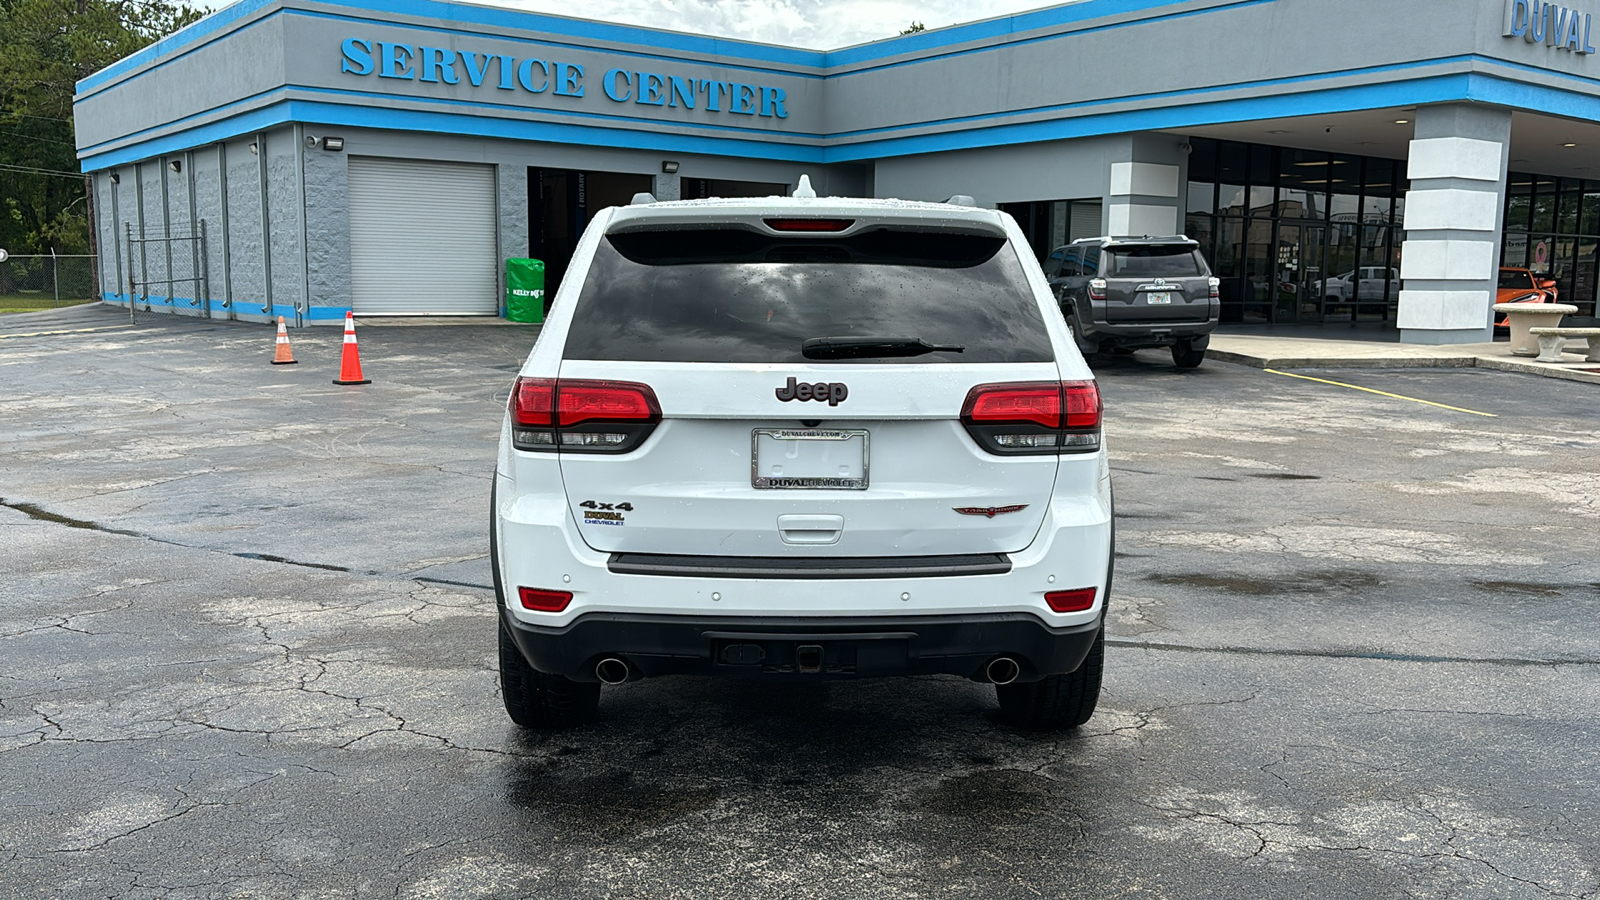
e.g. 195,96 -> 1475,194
75,0 -> 1600,343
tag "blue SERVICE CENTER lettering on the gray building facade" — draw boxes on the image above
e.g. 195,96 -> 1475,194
339,37 -> 789,119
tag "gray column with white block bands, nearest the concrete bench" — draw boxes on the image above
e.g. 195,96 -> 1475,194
1398,104 -> 1510,344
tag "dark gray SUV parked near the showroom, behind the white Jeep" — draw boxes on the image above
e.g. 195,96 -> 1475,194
1045,235 -> 1221,368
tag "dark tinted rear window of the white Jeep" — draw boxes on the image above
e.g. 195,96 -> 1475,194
565,229 -> 1054,364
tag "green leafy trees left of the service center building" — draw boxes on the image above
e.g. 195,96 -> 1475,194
0,0 -> 203,253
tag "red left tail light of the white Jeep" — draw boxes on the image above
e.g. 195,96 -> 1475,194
509,378 -> 661,453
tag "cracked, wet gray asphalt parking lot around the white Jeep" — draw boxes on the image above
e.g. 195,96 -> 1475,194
0,304 -> 1600,900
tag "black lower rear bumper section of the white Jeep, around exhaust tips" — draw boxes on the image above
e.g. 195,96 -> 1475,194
501,607 -> 1101,682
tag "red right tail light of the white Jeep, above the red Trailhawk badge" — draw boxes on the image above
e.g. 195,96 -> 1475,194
962,381 -> 1101,456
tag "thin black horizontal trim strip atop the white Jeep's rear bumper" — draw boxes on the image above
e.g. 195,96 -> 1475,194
606,552 -> 1011,578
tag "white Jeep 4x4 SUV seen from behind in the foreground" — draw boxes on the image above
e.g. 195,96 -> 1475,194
490,188 -> 1114,729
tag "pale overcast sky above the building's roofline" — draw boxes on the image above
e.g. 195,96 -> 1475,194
302,0 -> 1061,50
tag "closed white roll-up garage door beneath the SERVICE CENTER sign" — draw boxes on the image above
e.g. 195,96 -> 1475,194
350,157 -> 499,315
